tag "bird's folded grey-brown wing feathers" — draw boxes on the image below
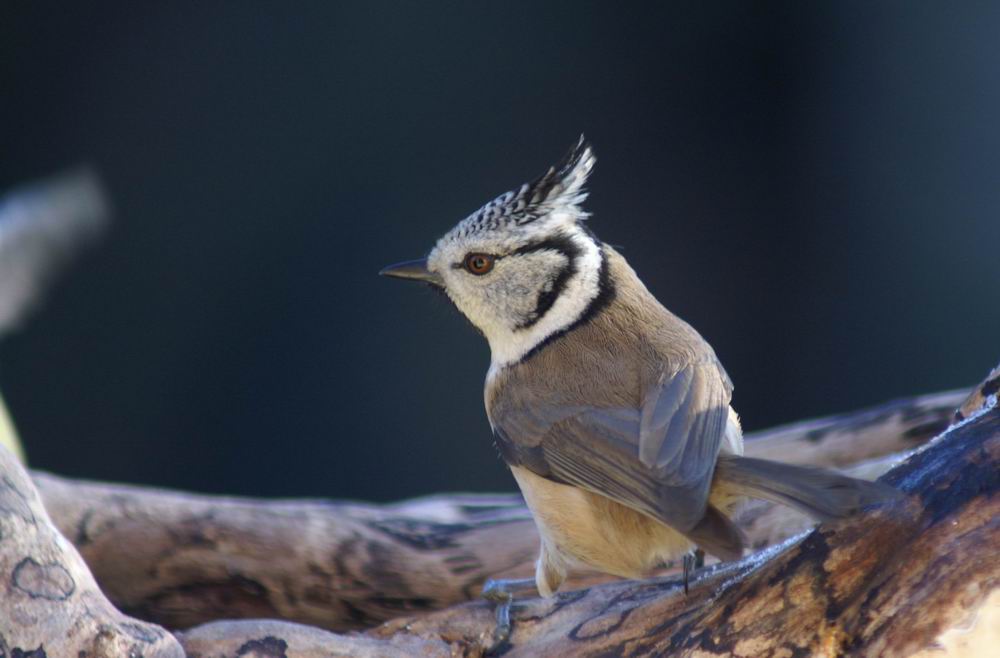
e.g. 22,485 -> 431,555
491,361 -> 732,532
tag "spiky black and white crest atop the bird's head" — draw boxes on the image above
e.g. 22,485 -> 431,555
458,135 -> 597,235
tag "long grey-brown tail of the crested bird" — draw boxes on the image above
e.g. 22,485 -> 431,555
715,455 -> 900,521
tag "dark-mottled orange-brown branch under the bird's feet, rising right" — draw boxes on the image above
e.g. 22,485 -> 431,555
179,374 -> 1000,658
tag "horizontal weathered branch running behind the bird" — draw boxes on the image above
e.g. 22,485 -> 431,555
34,384 -> 965,630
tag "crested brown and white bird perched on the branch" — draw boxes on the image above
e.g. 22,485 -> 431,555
380,135 -> 895,642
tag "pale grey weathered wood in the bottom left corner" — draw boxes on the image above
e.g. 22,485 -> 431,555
0,436 -> 184,658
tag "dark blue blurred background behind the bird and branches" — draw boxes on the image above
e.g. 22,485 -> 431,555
0,2 -> 1000,500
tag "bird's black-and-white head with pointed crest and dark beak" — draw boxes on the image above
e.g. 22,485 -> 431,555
381,136 -> 606,365
